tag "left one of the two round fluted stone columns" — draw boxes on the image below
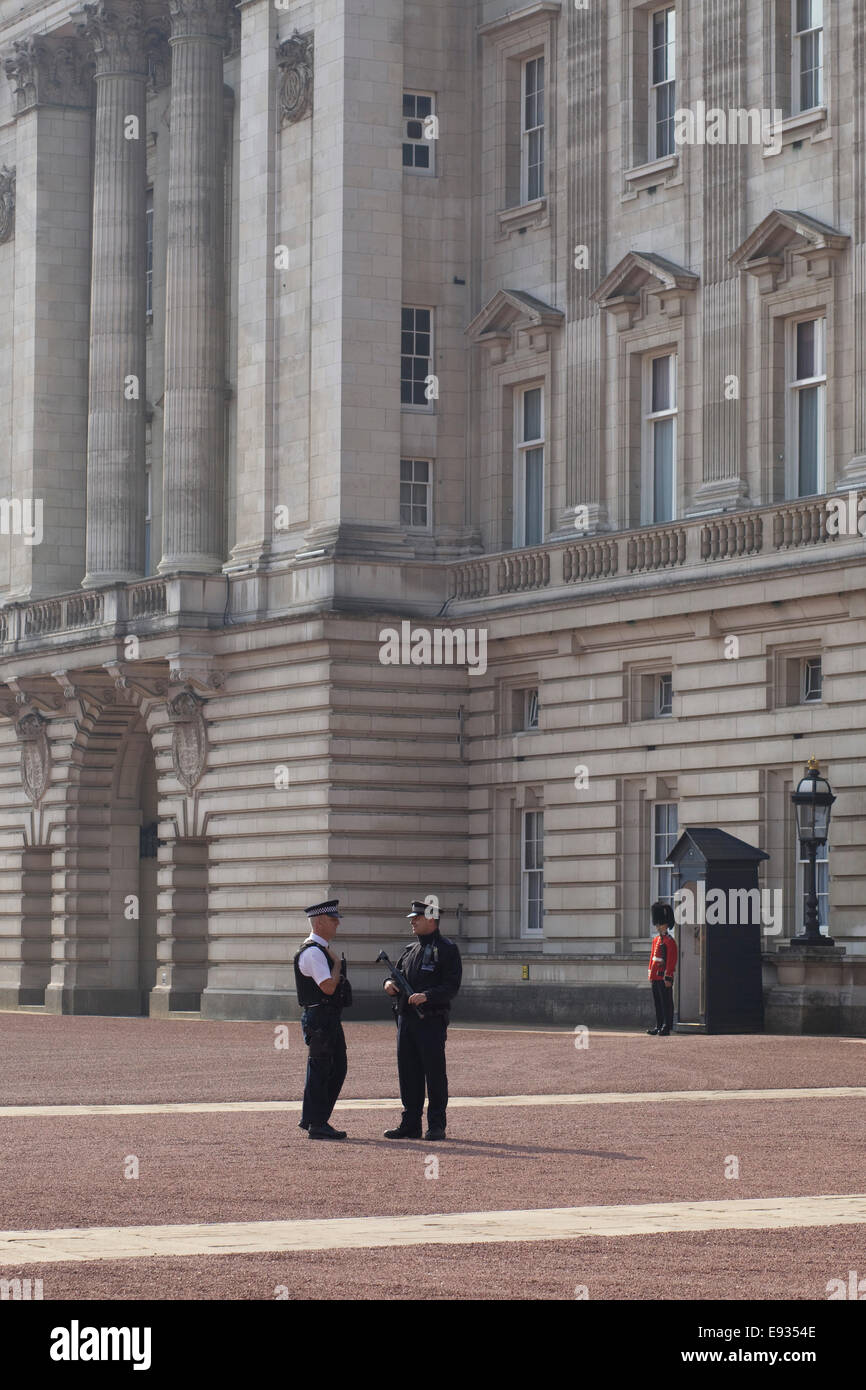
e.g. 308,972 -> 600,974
82,0 -> 147,588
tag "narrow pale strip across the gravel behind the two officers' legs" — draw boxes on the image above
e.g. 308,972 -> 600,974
0,1086 -> 866,1120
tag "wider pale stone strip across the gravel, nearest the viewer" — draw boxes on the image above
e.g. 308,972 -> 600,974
0,1194 -> 866,1266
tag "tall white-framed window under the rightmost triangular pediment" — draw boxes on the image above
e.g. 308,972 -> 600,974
787,318 -> 827,498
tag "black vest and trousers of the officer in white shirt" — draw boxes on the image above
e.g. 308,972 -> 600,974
295,941 -> 352,1129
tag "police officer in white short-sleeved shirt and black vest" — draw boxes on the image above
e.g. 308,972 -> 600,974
295,898 -> 352,1140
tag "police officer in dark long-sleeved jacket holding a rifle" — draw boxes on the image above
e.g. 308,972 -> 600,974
385,898 -> 463,1140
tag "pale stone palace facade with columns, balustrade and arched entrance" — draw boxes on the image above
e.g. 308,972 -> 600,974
0,0 -> 866,1031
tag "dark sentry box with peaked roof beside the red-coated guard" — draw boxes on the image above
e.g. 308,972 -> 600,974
667,826 -> 767,1033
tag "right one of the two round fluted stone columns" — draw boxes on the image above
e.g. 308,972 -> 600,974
158,0 -> 225,574
